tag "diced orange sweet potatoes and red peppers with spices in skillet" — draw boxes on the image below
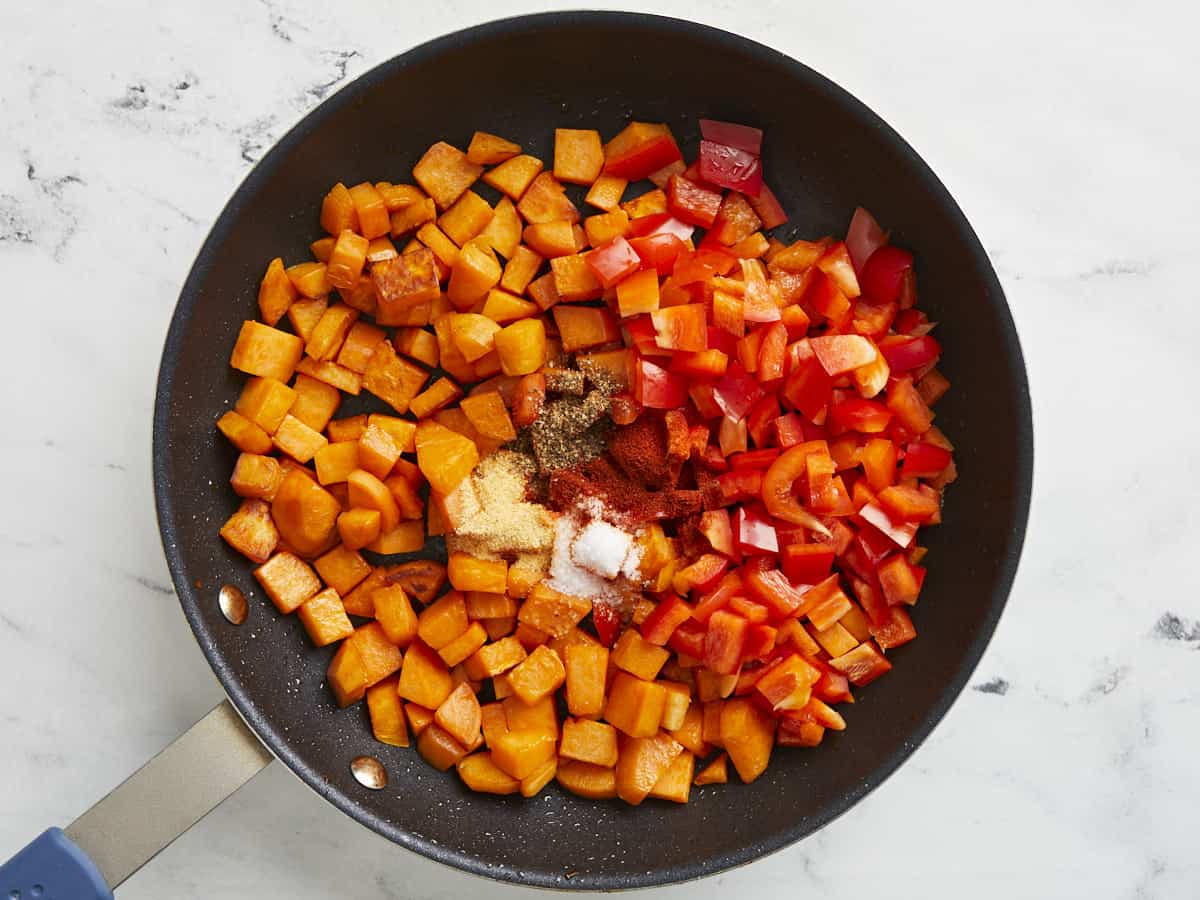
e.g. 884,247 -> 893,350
217,114 -> 956,804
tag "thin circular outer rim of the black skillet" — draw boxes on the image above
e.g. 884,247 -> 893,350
152,11 -> 1033,890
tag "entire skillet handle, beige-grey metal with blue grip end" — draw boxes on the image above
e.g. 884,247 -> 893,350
0,700 -> 271,900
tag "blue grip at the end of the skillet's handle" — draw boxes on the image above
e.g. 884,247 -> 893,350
0,828 -> 113,900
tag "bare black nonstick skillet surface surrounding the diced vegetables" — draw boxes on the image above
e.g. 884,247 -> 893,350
154,12 -> 1032,889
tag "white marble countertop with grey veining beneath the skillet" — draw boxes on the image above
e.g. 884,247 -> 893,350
0,0 -> 1200,900
